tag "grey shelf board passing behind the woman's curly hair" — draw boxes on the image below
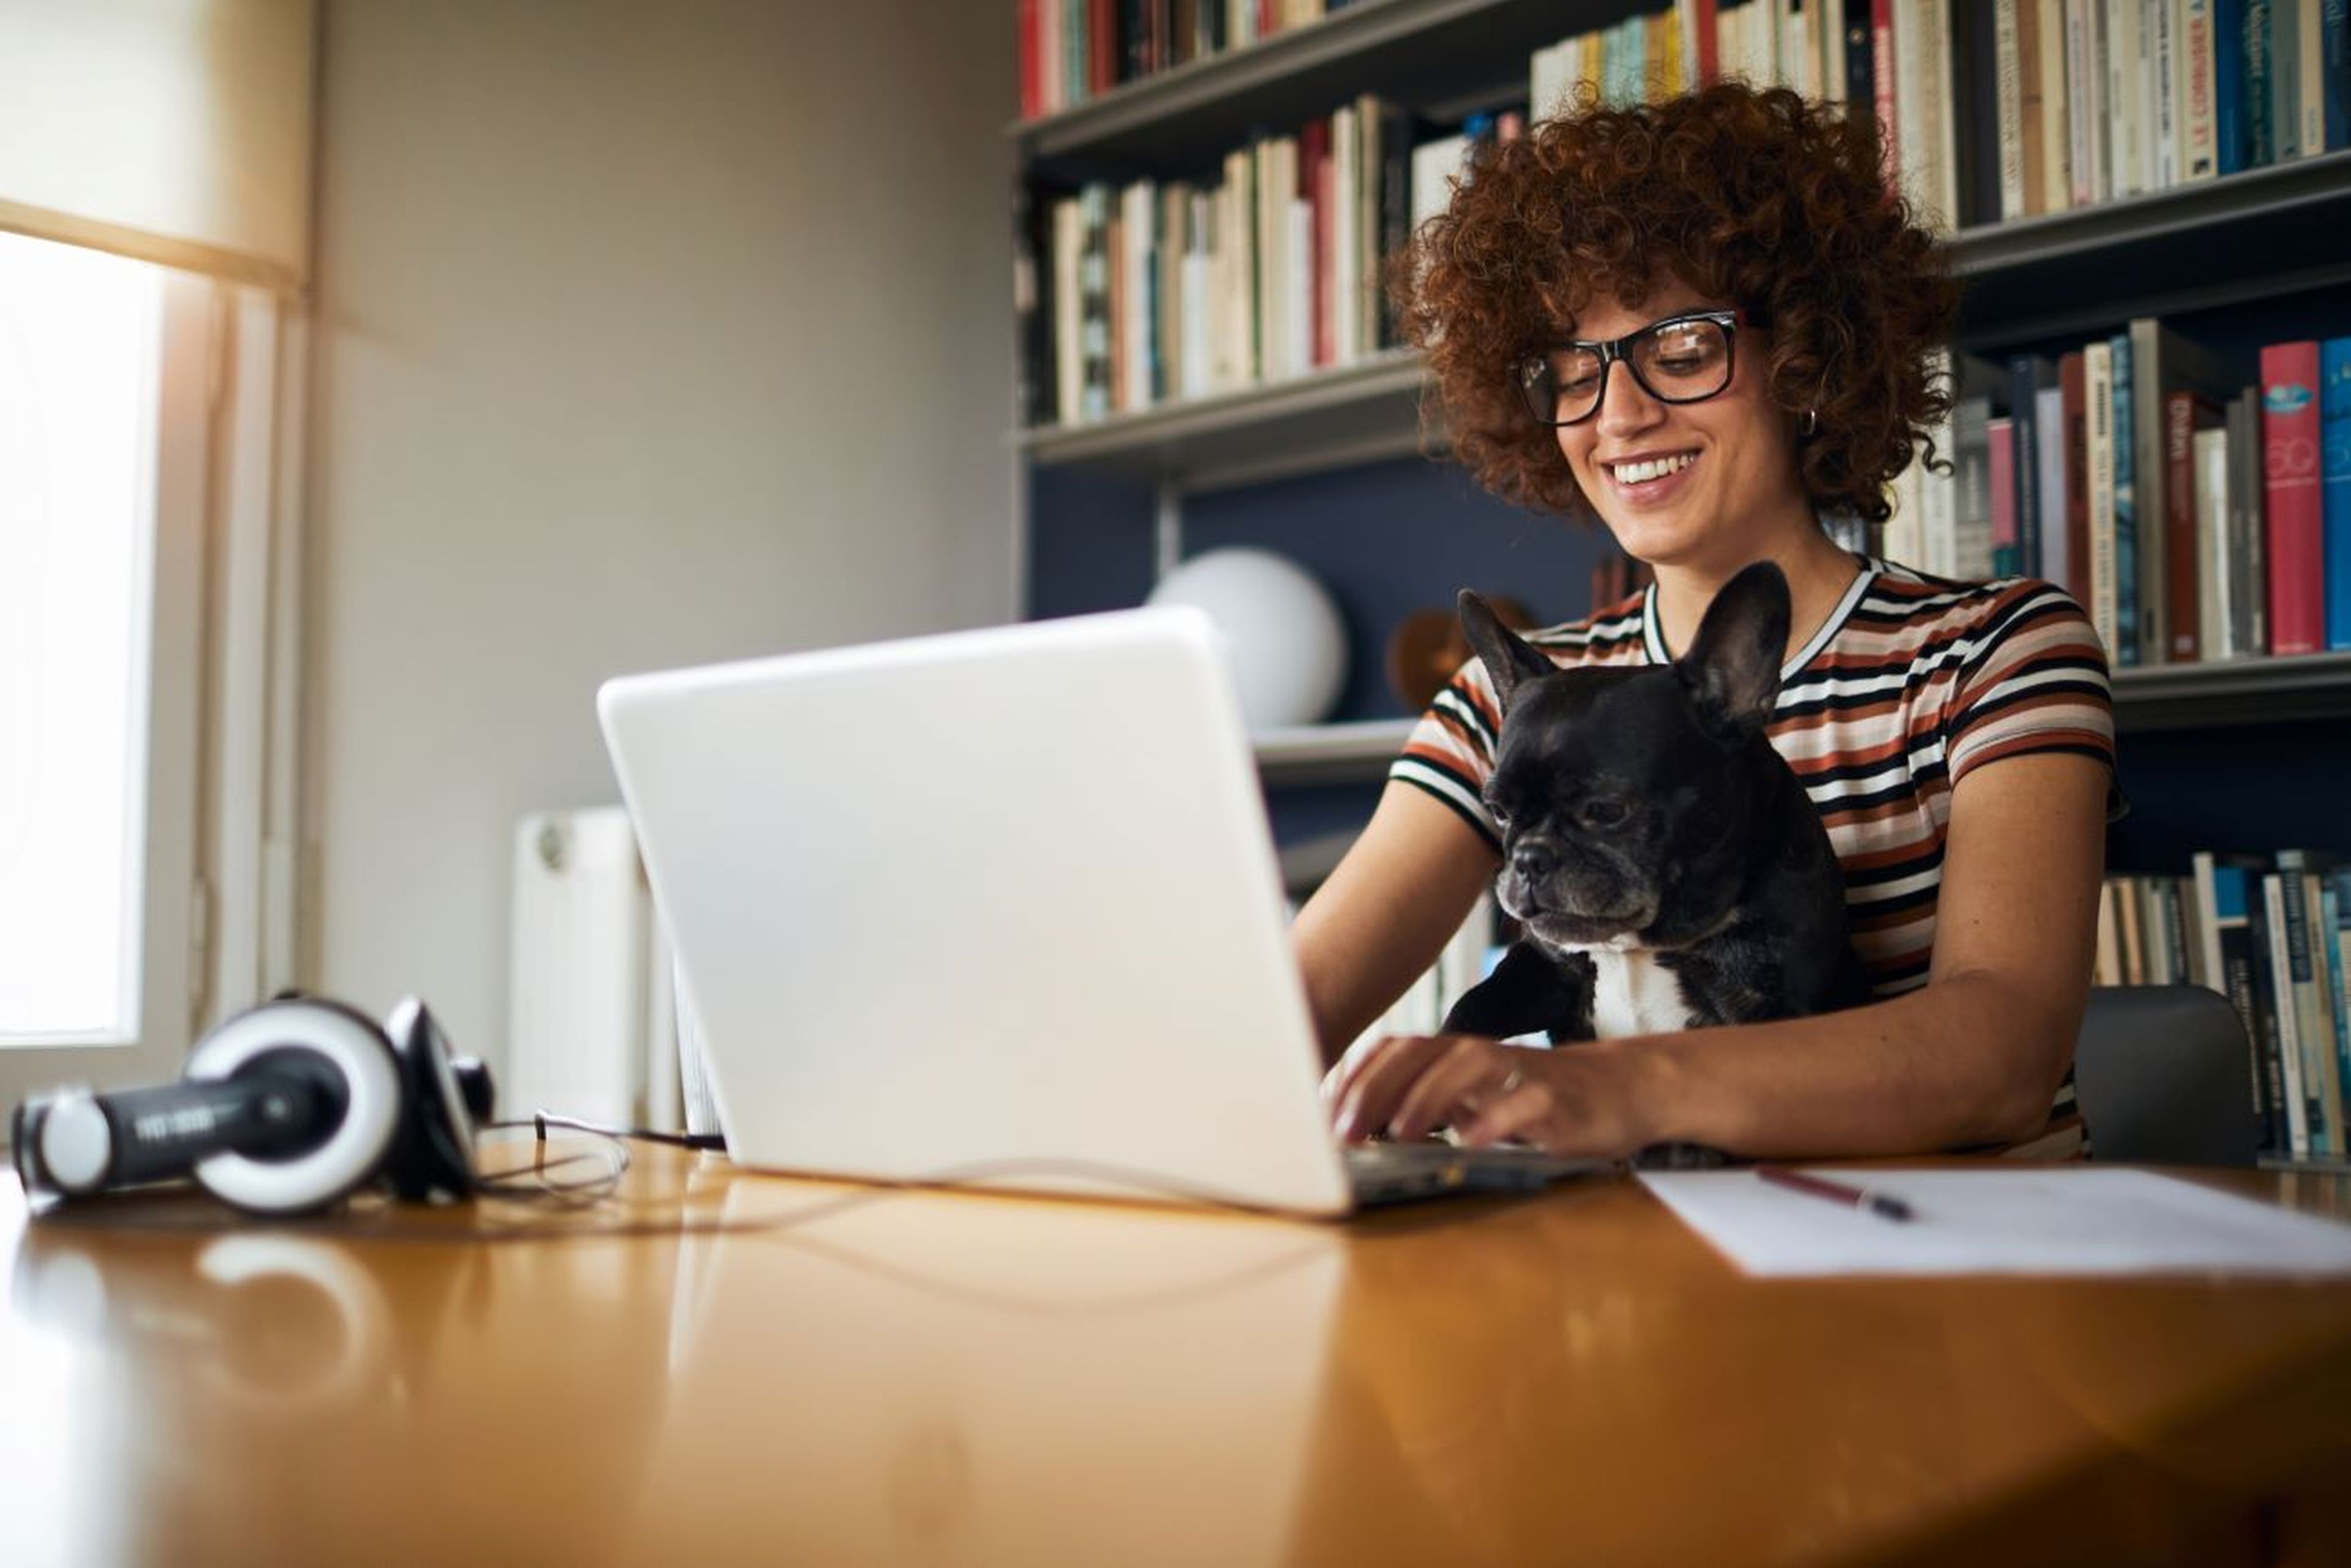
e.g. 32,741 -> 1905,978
1018,154 -> 2351,491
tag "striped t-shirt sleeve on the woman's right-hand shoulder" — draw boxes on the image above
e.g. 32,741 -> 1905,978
1944,580 -> 2123,820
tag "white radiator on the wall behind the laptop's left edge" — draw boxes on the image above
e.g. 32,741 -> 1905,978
498,806 -> 682,1128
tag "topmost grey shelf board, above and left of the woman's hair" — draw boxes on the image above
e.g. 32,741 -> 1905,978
1007,0 -> 1624,181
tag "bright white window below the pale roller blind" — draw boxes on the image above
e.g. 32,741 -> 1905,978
0,233 -> 214,1103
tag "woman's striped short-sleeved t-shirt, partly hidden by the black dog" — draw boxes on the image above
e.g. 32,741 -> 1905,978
1389,560 -> 2118,1157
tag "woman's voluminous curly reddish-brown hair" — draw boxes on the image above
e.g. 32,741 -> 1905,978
1387,82 -> 1959,522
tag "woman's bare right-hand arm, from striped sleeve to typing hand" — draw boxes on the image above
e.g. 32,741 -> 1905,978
1330,752 -> 2107,1157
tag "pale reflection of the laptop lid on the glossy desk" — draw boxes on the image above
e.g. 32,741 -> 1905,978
628,1178 -> 1344,1563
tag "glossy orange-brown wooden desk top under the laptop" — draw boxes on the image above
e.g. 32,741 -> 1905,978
0,1152 -> 2351,1568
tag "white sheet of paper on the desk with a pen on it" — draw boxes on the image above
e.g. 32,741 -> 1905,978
1641,1166 -> 2351,1277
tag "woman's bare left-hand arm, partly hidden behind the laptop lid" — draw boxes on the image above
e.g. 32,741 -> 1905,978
1291,783 -> 1500,1062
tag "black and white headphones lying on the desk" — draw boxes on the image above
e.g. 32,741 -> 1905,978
9,997 -> 492,1215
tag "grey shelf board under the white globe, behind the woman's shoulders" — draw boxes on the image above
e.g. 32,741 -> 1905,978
1256,653 -> 2351,787
